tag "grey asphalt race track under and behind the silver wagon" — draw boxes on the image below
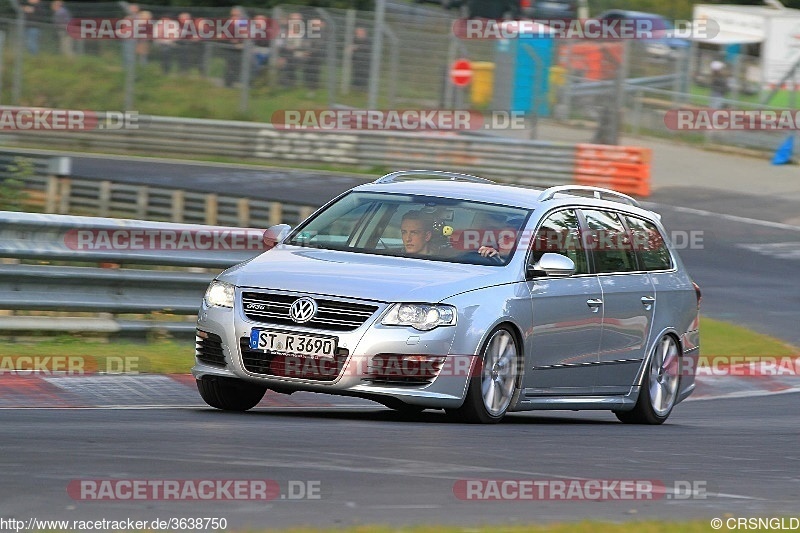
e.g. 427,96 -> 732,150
0,156 -> 800,530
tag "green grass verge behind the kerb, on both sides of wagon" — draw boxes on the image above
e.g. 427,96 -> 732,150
0,318 -> 800,374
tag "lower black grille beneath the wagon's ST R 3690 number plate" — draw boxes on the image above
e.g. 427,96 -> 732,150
239,337 -> 350,381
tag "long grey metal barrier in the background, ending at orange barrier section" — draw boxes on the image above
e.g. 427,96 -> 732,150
0,116 -> 649,194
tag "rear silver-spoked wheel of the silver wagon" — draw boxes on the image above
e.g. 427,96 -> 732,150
614,335 -> 680,425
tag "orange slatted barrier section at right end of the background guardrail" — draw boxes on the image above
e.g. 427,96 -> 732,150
574,144 -> 653,196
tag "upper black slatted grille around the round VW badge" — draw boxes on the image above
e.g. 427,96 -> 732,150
242,292 -> 378,331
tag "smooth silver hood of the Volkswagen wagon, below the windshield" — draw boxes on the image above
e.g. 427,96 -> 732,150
218,245 -> 513,303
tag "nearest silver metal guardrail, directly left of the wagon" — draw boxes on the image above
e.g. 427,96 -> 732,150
0,212 -> 265,334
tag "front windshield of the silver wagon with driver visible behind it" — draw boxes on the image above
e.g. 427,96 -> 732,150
286,192 -> 530,265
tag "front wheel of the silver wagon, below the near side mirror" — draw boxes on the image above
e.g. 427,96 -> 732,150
448,326 -> 522,424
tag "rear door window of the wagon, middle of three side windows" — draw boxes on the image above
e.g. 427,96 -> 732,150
582,209 -> 636,274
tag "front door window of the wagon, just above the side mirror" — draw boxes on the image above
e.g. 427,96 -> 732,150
530,209 -> 589,274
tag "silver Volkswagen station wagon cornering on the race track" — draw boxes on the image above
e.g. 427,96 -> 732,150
192,170 -> 700,424
